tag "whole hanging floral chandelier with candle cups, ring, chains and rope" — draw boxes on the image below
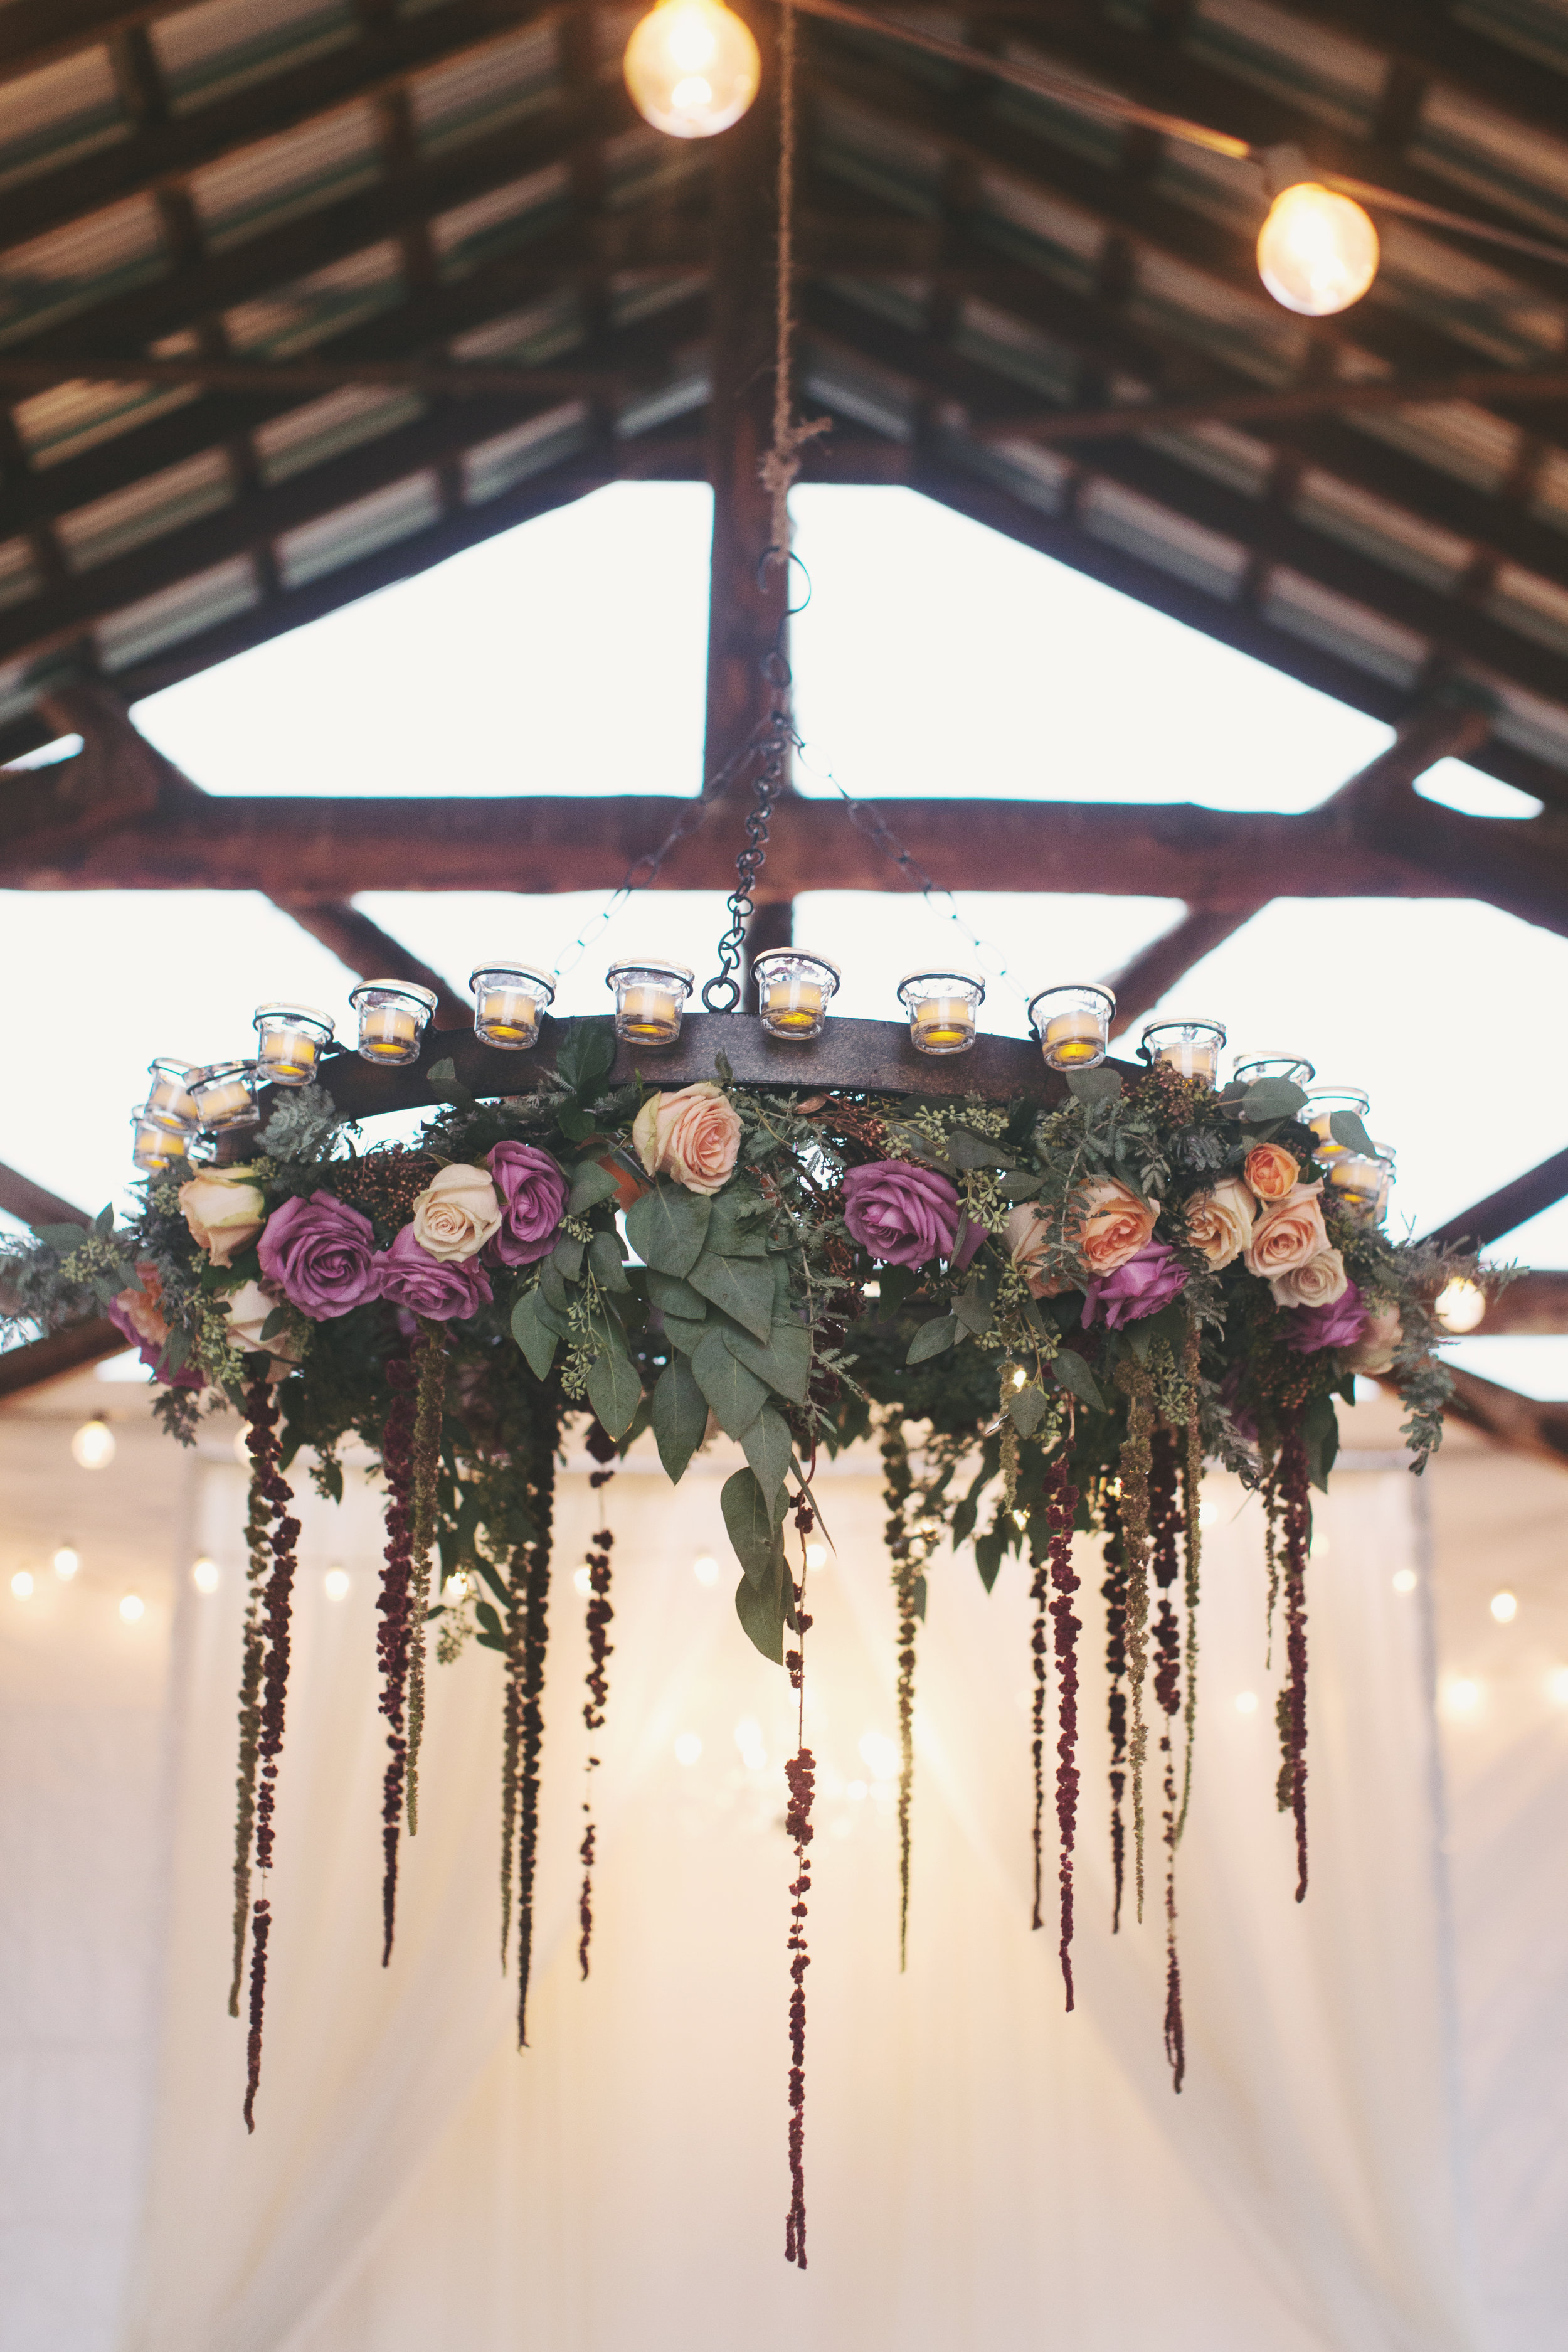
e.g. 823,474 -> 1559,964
0,14 -> 1490,2267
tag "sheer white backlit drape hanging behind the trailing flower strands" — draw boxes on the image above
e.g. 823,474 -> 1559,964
125,1430 -> 1476,2352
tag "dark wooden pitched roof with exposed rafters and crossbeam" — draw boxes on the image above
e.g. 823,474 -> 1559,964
0,0 -> 1568,1420
